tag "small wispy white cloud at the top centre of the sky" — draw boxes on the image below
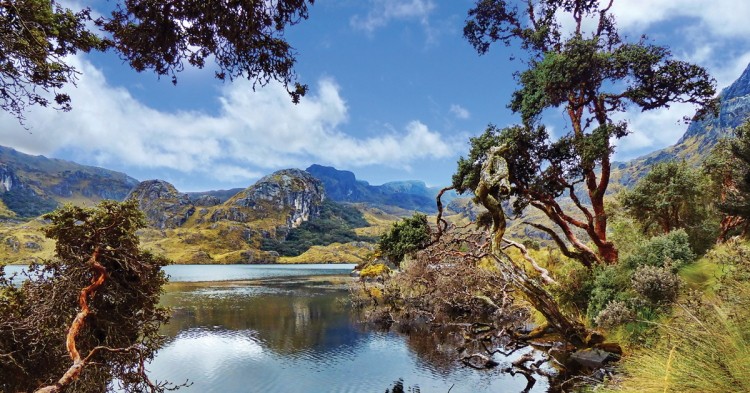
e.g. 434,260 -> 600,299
349,0 -> 435,36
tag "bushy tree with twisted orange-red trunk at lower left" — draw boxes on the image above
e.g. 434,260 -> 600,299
0,201 -> 169,392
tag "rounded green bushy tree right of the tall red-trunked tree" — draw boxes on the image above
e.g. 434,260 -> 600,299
619,161 -> 718,251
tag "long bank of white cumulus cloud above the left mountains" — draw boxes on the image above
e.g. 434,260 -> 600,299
0,58 -> 455,185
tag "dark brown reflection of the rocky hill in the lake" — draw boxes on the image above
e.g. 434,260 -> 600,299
161,283 -> 359,354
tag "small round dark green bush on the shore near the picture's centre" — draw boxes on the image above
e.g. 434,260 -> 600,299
378,213 -> 431,265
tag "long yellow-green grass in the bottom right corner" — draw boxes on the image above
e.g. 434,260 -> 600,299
607,239 -> 750,393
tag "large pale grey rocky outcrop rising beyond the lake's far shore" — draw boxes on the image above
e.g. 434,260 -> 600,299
210,169 -> 325,228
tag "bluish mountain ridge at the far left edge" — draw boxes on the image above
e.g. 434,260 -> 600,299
0,146 -> 138,218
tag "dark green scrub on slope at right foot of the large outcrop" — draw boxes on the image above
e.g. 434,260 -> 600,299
261,200 -> 372,256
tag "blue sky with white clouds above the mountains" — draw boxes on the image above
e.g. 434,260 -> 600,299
0,0 -> 750,192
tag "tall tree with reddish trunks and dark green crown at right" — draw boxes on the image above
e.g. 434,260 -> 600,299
462,0 -> 716,266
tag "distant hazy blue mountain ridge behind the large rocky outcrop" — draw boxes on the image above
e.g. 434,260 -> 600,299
306,164 -> 455,213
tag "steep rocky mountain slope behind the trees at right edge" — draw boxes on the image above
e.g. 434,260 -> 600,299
612,65 -> 750,187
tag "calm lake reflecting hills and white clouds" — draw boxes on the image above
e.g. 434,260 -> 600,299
1,265 -> 547,393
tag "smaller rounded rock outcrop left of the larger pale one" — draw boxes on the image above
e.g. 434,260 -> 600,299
125,180 -> 195,229
